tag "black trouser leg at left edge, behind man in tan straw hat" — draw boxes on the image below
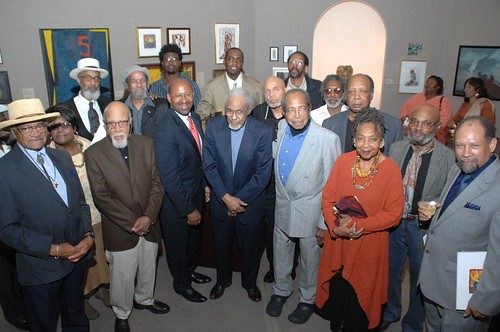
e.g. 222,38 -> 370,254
0,242 -> 24,324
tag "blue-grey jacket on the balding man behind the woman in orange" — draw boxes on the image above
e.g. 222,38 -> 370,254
323,111 -> 403,155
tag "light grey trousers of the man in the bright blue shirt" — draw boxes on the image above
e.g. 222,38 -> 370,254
273,226 -> 321,304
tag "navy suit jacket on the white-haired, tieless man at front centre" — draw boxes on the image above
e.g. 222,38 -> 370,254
203,116 -> 272,224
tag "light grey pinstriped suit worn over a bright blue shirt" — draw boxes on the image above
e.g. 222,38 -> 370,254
274,120 -> 341,303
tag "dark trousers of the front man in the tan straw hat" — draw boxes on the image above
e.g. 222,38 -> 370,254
22,261 -> 89,332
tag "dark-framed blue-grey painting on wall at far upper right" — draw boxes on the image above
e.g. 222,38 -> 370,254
453,45 -> 500,100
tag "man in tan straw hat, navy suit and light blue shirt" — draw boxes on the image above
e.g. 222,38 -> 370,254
0,99 -> 94,331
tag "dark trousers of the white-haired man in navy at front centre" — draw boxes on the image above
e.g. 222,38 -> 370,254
212,217 -> 262,289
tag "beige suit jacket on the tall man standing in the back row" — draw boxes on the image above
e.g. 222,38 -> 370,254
196,73 -> 264,121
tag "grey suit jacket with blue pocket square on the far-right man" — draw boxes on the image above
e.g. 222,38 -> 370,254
420,159 -> 500,316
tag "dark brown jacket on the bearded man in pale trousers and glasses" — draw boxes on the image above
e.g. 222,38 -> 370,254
85,135 -> 163,251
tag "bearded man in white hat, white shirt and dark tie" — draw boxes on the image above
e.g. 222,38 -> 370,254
65,58 -> 111,142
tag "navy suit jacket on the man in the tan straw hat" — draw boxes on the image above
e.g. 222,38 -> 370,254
0,145 -> 92,286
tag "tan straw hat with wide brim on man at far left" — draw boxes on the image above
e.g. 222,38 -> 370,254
0,98 -> 60,130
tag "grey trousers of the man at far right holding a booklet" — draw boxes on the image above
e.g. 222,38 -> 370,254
424,297 -> 489,332
